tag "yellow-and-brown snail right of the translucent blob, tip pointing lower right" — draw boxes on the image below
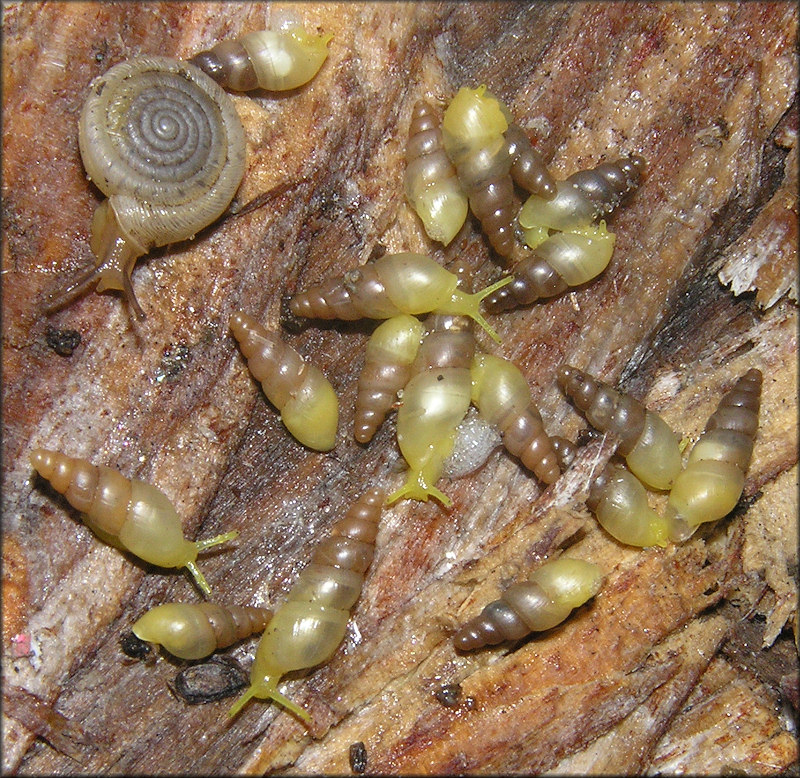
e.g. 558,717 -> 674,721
472,353 -> 561,484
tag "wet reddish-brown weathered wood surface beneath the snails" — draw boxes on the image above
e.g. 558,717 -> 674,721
2,3 -> 798,774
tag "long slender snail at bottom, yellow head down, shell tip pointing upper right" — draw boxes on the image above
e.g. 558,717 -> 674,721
229,489 -> 383,722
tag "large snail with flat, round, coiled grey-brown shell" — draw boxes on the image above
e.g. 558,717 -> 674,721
48,56 -> 245,319
